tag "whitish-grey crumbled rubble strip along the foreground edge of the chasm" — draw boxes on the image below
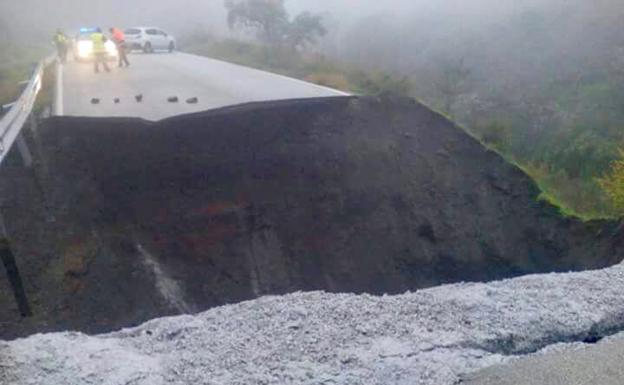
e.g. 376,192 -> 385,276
0,264 -> 624,385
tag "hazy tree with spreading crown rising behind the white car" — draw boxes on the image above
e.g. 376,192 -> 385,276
225,0 -> 327,48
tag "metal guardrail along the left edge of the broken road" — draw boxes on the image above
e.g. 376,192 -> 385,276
0,56 -> 55,164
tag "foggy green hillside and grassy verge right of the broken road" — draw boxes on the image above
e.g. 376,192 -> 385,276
187,0 -> 624,218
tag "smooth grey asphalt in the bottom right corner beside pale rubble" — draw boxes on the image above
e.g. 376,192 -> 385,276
462,338 -> 624,385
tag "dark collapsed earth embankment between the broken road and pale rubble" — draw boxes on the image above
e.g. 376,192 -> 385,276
0,98 -> 624,338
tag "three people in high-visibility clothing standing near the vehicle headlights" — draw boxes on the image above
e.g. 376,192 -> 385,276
54,27 -> 130,73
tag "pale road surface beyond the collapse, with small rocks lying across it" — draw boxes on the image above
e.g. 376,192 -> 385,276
56,53 -> 347,120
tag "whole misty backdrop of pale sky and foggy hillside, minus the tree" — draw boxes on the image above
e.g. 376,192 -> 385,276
0,0 -> 624,215
